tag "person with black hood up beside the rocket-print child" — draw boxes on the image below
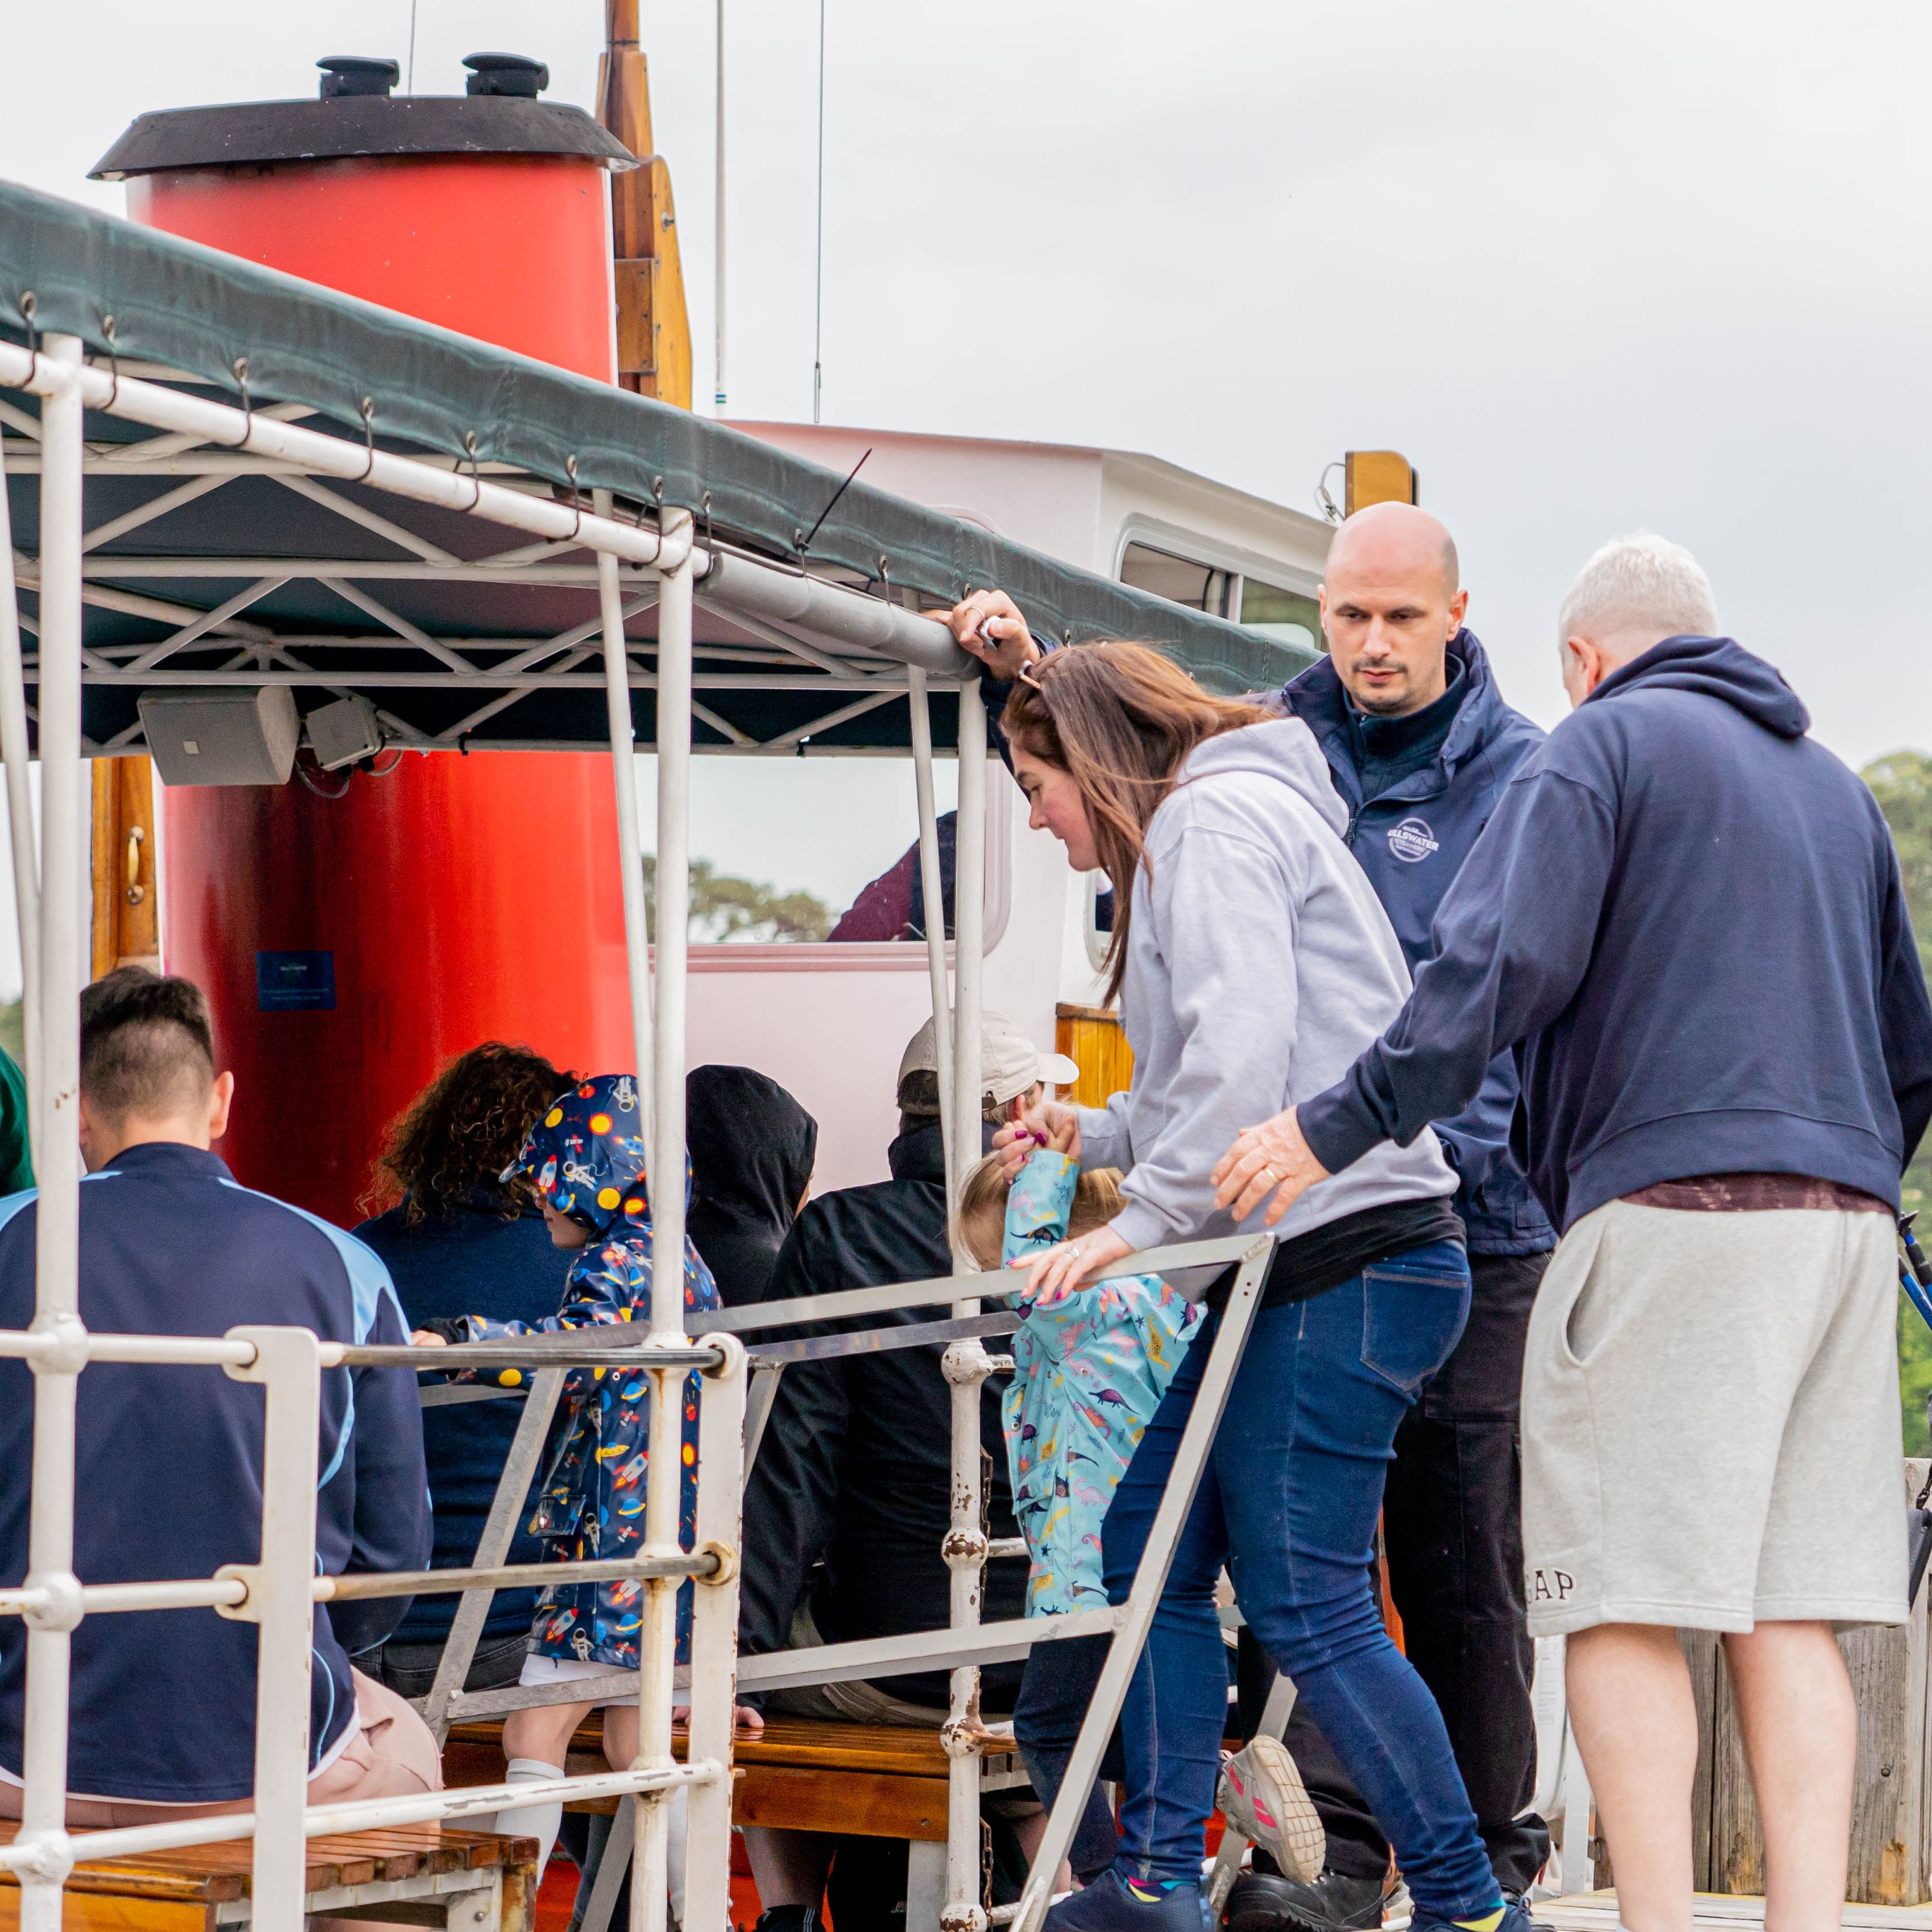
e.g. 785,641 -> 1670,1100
684,1066 -> 819,1308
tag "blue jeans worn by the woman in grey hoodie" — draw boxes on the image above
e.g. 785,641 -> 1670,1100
1103,1242 -> 1498,1918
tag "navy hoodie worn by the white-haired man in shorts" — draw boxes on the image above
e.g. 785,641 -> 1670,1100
1300,638 -> 1932,1229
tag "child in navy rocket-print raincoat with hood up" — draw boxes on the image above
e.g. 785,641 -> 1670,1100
417,1074 -> 721,1671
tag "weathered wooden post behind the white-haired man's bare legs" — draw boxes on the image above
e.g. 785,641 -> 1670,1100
1693,1459 -> 1932,1905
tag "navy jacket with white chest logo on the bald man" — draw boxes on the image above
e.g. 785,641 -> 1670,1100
1273,630 -> 1555,1254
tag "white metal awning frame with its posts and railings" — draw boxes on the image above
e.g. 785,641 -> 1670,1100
0,297 -> 1298,1932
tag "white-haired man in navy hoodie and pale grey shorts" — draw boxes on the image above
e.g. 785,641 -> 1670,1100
1217,535 -> 1932,1932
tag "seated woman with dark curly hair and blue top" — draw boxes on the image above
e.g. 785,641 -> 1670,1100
355,1040 -> 574,1696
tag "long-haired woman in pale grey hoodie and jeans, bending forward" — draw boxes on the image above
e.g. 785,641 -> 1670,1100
981,618 -> 1528,1932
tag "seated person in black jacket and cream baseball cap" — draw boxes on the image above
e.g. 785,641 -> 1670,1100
738,1013 -> 1078,1932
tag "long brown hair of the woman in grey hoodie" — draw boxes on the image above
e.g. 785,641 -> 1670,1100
1003,642 -> 1271,1001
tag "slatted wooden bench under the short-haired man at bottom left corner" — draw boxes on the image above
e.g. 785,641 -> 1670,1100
0,1820 -> 537,1932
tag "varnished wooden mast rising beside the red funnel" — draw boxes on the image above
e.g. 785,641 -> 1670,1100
597,0 -> 692,410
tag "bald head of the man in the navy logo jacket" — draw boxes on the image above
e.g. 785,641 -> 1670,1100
1322,503 -> 1468,717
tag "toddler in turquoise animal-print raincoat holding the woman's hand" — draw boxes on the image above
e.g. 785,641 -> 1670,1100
960,1145 -> 1202,1617
